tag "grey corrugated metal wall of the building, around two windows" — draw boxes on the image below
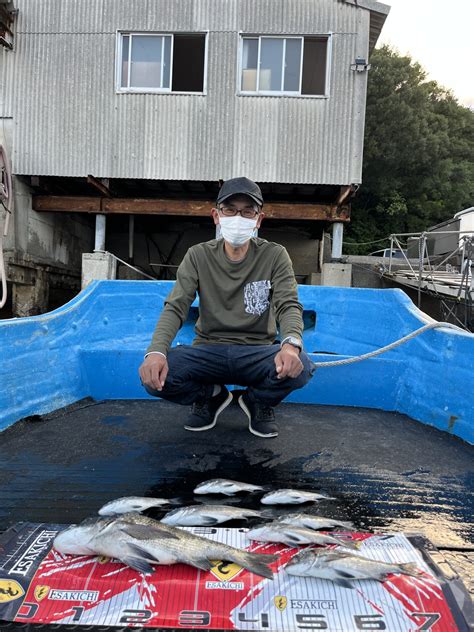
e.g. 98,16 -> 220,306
0,0 -> 370,184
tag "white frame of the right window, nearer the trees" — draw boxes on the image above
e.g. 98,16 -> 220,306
237,32 -> 332,99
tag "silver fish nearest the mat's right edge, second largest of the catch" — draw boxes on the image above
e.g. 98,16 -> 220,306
285,549 -> 422,588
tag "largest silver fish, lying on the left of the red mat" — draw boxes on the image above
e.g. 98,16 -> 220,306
53,513 -> 278,579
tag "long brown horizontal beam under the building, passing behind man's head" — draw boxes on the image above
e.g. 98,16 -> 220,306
33,196 -> 350,222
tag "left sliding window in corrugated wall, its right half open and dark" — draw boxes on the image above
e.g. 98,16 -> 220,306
117,33 -> 206,93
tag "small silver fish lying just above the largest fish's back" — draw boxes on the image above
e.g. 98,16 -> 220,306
160,505 -> 262,527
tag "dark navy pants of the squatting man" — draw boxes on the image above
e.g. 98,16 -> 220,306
145,344 -> 315,406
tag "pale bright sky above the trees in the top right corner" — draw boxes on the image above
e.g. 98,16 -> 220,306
377,0 -> 474,108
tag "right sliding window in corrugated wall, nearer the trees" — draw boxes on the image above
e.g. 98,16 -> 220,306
240,36 -> 329,96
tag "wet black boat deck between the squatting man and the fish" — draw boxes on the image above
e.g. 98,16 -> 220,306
0,400 -> 474,593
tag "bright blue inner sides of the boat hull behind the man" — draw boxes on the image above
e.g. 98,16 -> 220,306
0,281 -> 474,443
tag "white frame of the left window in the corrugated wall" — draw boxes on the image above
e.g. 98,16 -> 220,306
115,30 -> 209,96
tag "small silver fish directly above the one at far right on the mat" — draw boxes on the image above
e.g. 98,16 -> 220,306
246,521 -> 359,549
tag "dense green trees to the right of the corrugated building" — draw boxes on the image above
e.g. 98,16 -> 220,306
346,46 -> 474,254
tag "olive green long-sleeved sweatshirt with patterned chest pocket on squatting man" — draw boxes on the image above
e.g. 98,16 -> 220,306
147,238 -> 303,355
